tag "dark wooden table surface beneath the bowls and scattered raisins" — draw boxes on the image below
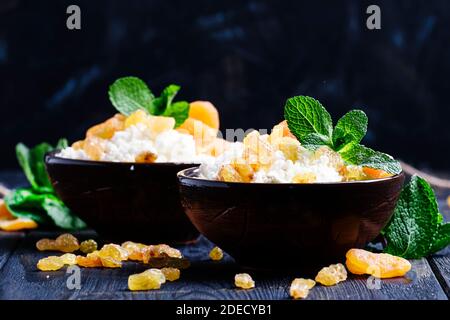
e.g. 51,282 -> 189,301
0,172 -> 450,300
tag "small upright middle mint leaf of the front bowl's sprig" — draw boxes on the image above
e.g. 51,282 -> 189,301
333,110 -> 368,150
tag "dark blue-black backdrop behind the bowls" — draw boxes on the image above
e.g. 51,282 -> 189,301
0,0 -> 450,171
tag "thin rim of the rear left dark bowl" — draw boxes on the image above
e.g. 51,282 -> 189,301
44,149 -> 200,168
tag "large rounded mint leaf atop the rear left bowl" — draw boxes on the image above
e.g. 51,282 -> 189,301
109,77 -> 155,116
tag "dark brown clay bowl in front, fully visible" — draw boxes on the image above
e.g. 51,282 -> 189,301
178,168 -> 404,269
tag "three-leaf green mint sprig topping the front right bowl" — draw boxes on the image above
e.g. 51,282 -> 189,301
284,96 -> 402,174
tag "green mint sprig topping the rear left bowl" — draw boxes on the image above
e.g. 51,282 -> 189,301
109,77 -> 189,127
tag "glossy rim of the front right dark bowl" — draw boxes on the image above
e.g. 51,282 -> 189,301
177,167 -> 405,188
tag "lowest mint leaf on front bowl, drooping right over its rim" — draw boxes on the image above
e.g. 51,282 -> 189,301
338,143 -> 402,174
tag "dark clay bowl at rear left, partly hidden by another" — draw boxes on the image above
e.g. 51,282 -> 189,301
45,152 -> 198,243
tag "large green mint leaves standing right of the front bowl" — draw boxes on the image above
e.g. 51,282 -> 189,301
383,176 -> 450,259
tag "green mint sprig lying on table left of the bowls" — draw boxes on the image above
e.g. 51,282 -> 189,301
5,139 -> 86,230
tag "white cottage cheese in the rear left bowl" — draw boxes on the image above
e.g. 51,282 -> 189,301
58,123 -> 208,163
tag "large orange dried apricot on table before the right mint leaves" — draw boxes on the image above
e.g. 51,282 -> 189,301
345,249 -> 411,278
